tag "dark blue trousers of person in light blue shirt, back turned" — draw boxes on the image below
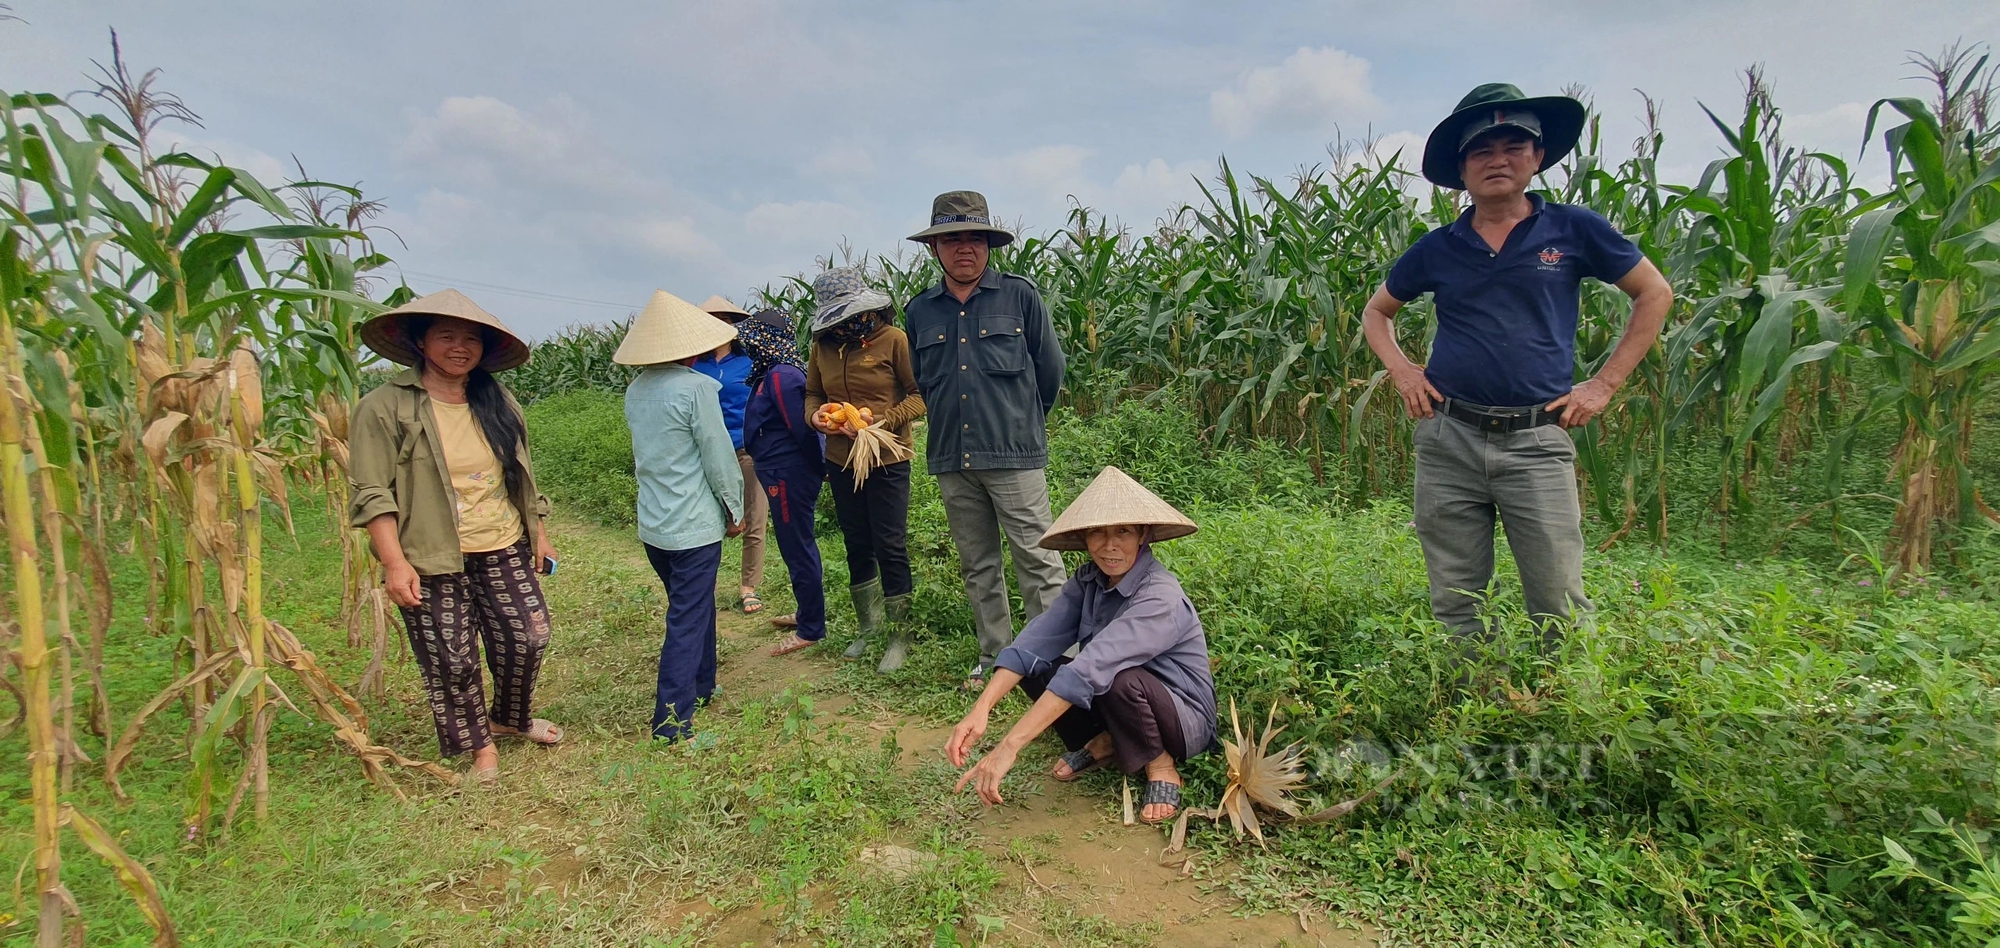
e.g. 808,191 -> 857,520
644,542 -> 722,740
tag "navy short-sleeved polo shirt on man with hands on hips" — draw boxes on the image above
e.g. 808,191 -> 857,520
1386,194 -> 1646,408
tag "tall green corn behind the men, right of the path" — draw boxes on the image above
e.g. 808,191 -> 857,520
760,48 -> 2000,572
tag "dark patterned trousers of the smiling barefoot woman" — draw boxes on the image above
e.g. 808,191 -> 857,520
402,536 -> 548,758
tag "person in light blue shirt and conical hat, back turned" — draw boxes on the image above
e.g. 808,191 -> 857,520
612,290 -> 744,740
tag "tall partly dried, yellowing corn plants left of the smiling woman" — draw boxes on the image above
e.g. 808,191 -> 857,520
0,44 -> 454,946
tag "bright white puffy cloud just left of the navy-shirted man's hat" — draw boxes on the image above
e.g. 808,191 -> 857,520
1208,46 -> 1380,138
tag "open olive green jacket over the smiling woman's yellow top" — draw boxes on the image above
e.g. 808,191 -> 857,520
348,368 -> 548,576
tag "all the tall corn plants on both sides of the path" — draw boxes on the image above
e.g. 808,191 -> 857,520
0,29 -> 2000,946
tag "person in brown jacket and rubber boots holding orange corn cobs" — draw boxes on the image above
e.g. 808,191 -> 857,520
806,266 -> 924,674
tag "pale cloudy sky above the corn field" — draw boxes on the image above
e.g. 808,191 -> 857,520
0,0 -> 2000,334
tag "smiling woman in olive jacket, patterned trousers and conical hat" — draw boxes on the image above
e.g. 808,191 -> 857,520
348,290 -> 562,782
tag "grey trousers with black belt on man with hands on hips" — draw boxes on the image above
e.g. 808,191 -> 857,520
1416,412 -> 1594,648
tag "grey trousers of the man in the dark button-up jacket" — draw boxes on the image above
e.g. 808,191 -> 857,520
938,468 -> 1068,668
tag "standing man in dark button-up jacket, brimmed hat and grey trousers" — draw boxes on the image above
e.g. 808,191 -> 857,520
904,190 -> 1066,690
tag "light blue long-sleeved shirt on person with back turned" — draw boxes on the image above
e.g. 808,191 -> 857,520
626,364 -> 744,550
